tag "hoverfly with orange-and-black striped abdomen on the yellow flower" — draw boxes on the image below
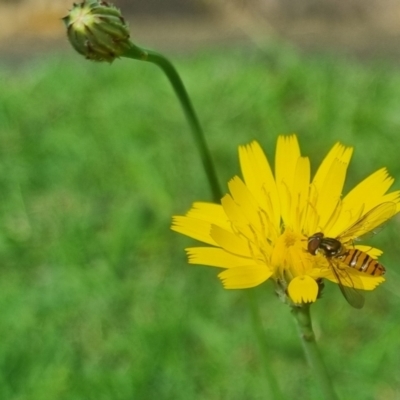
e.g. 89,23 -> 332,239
307,202 -> 396,308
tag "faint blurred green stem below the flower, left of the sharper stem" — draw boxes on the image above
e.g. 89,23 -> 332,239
246,290 -> 285,400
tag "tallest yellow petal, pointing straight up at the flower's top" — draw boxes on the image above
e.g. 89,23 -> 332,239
275,135 -> 300,226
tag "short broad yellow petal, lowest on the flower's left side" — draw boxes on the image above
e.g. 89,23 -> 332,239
218,265 -> 272,289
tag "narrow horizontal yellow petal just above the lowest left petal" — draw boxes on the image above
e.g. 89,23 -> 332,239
186,247 -> 252,268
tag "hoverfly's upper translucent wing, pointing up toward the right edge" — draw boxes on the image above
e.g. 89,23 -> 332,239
337,202 -> 397,243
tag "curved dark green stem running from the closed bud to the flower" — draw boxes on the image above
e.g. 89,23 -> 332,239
123,44 -> 222,203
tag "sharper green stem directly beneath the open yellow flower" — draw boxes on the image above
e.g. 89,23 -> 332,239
292,304 -> 338,400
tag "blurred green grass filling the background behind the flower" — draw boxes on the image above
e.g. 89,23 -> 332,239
0,42 -> 400,400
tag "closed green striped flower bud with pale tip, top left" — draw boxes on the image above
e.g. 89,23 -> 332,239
63,0 -> 131,62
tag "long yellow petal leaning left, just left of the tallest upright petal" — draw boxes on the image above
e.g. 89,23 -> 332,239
239,142 -> 281,231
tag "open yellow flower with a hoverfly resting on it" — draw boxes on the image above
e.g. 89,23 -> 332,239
172,135 -> 400,308
